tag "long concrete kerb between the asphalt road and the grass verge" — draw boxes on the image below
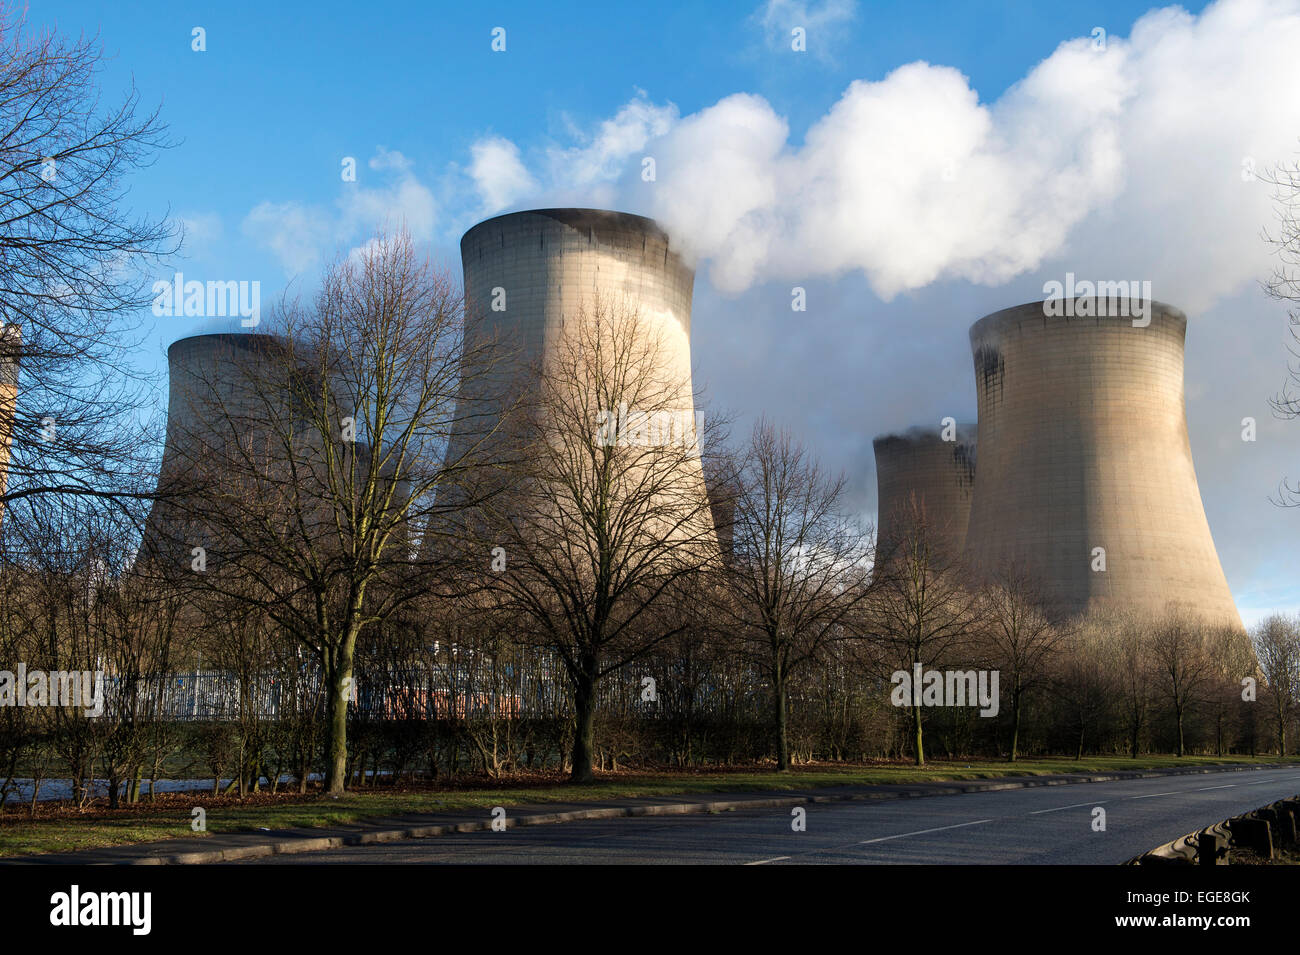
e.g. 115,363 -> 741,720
27,765 -> 1289,865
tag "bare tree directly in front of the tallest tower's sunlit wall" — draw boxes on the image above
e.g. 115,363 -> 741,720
483,298 -> 718,782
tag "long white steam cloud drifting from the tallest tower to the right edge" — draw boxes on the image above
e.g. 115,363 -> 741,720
483,0 -> 1300,309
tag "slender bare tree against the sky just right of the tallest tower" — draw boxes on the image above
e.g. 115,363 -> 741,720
719,420 -> 870,772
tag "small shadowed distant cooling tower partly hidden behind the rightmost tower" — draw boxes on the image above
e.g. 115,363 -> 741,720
872,425 -> 975,564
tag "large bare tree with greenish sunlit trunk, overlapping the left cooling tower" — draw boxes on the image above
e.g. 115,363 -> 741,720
156,231 -> 482,793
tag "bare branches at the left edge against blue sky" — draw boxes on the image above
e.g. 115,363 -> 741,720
0,6 -> 177,522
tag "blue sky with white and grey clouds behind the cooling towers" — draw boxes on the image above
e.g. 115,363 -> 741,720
29,0 -> 1300,621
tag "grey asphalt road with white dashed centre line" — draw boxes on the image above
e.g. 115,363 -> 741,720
233,767 -> 1300,865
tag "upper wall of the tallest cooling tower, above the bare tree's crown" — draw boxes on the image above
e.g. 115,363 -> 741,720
449,209 -> 705,545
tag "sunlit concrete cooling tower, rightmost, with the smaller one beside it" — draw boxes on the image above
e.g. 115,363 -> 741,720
966,299 -> 1242,628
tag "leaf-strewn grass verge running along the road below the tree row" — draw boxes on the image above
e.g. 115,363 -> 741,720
0,756 -> 1295,856
